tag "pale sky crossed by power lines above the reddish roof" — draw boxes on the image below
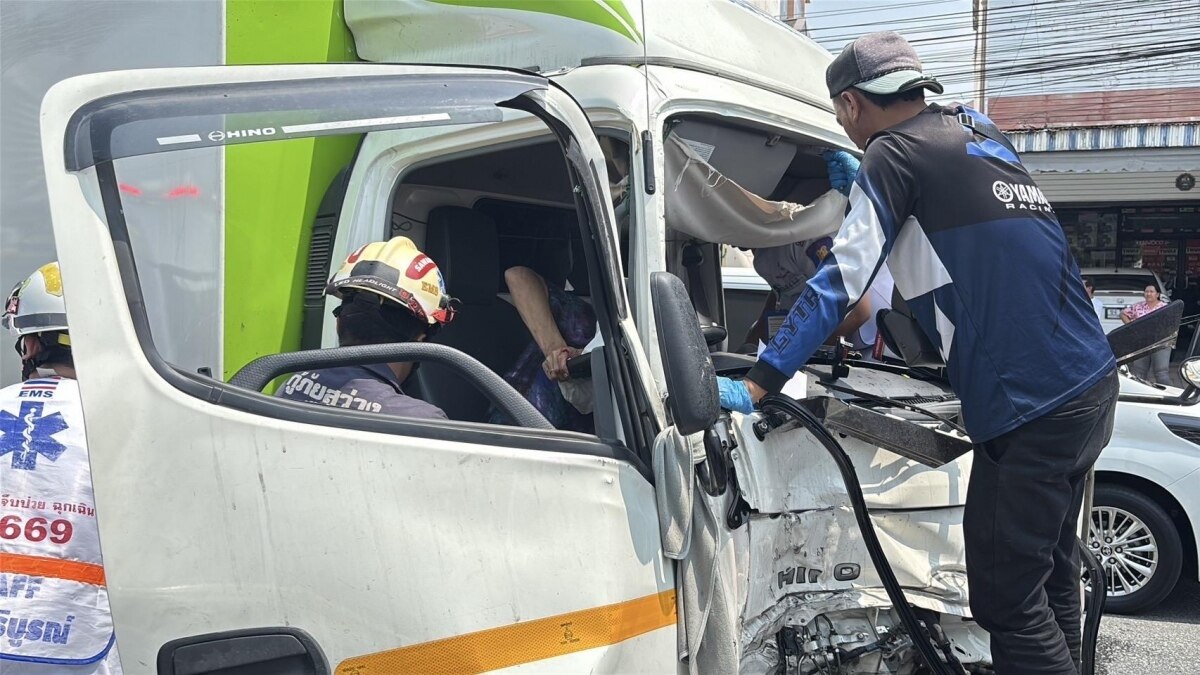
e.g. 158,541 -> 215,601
806,0 -> 1200,106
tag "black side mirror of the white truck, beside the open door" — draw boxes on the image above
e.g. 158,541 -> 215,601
650,271 -> 721,436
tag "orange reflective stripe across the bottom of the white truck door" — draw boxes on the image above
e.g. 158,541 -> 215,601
337,590 -> 676,675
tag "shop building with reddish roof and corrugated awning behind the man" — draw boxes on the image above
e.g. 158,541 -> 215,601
989,88 -> 1200,297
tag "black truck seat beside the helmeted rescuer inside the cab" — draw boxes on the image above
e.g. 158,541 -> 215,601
408,207 -> 532,422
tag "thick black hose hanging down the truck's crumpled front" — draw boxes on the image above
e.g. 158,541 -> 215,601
758,394 -> 966,675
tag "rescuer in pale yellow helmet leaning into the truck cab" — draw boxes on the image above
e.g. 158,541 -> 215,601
275,237 -> 457,419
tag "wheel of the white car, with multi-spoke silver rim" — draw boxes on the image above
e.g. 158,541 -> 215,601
1087,485 -> 1183,614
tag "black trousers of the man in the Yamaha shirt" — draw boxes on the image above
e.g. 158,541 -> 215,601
962,372 -> 1118,675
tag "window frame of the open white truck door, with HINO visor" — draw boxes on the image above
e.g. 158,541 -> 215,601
64,67 -> 653,483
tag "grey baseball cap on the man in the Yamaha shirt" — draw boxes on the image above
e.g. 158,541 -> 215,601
826,30 -> 942,98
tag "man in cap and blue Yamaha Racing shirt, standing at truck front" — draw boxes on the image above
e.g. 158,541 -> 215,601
719,31 -> 1117,675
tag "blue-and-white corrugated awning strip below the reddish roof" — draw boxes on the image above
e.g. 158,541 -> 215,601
1004,123 -> 1200,153
